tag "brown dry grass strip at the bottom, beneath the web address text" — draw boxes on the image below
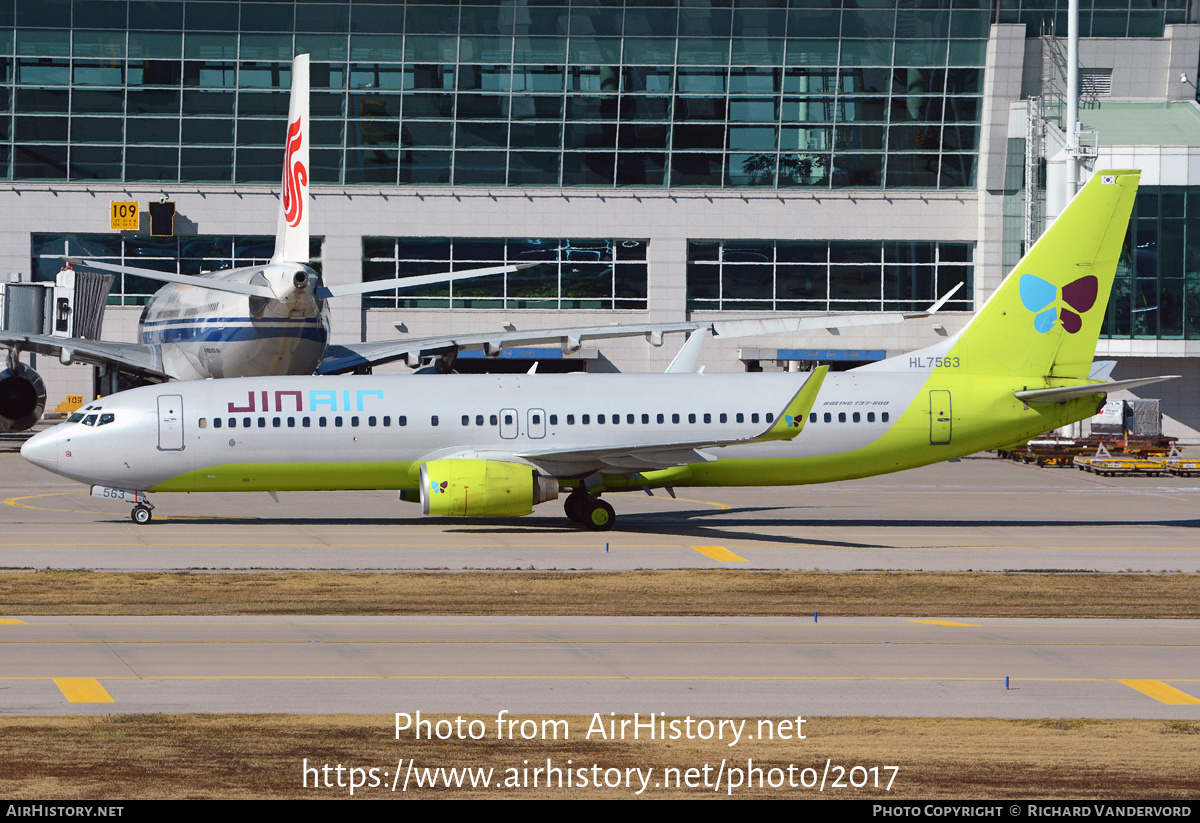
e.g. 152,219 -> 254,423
0,715 -> 1200,801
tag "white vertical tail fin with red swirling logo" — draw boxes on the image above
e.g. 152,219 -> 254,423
271,54 -> 310,263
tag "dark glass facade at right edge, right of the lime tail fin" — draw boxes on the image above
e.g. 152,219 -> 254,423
1100,186 -> 1200,340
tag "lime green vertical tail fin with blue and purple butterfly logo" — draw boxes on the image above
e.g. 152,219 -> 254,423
953,170 -> 1141,378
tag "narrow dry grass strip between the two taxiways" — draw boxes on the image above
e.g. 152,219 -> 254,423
0,570 -> 1200,618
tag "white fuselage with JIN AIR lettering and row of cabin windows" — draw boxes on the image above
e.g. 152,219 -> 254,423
22,371 -> 958,491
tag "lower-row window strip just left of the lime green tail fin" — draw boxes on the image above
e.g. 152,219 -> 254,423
688,240 -> 974,312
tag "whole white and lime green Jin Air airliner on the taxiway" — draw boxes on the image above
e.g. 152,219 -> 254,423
22,166 -> 1168,530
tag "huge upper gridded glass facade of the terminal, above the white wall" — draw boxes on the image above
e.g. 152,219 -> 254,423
0,0 -> 993,188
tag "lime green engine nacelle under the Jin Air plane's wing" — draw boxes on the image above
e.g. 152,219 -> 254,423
421,457 -> 558,517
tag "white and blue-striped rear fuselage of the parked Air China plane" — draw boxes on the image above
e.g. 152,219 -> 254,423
138,263 -> 329,380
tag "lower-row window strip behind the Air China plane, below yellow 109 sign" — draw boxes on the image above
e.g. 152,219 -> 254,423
30,233 -> 323,306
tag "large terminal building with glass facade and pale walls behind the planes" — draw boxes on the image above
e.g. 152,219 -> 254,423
0,0 -> 1200,437
